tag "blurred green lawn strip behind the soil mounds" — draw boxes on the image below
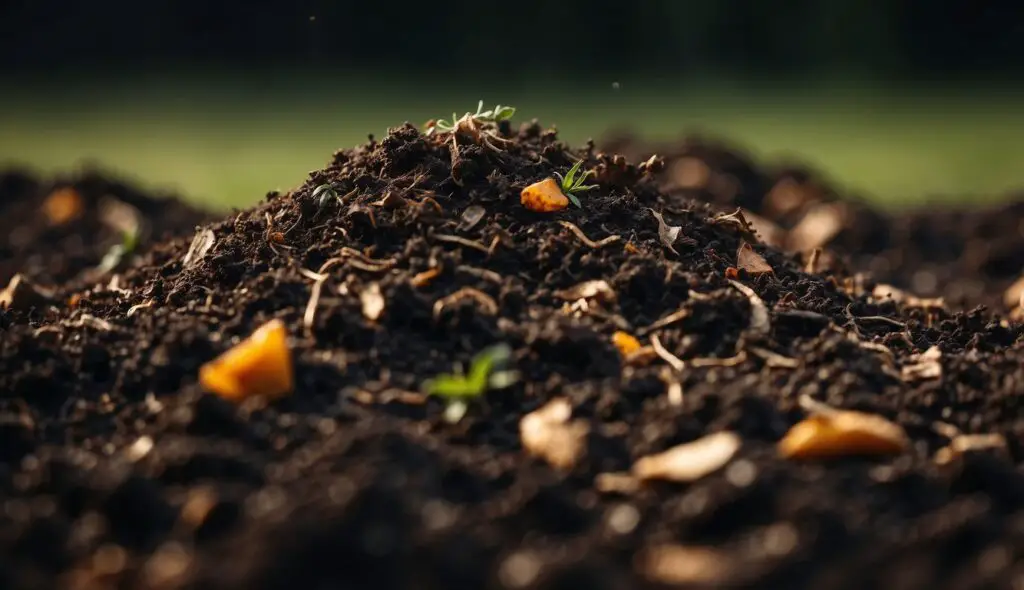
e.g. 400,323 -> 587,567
0,74 -> 1024,207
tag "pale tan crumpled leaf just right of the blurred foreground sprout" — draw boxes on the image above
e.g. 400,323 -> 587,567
519,397 -> 590,469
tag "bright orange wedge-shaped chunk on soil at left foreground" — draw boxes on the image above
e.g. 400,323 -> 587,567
199,320 -> 295,402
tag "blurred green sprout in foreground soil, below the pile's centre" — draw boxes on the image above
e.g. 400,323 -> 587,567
423,344 -> 519,423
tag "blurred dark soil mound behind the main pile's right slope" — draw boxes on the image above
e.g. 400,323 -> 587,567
602,133 -> 1024,311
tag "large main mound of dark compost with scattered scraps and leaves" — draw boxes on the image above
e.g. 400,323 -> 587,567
0,122 -> 1024,589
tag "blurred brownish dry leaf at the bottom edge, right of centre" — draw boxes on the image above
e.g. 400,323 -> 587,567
637,545 -> 736,588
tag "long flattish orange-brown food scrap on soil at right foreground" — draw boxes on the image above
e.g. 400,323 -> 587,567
778,410 -> 910,459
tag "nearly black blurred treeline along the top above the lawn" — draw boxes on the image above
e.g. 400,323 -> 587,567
0,0 -> 1024,78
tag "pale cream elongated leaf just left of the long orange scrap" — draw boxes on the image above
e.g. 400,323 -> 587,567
633,431 -> 742,482
